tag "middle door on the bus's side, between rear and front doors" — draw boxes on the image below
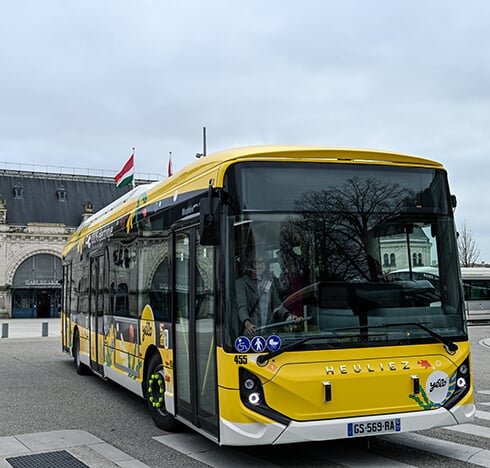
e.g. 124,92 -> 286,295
89,252 -> 105,375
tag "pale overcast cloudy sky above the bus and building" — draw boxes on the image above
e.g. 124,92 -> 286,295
0,0 -> 490,263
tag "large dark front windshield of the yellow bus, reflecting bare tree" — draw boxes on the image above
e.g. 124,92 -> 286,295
224,163 -> 466,352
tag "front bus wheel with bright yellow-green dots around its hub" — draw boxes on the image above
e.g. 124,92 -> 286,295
145,352 -> 177,432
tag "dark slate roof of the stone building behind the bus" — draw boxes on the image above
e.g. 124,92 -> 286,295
0,170 -> 144,227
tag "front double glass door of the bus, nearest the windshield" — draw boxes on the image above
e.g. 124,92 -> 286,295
173,227 -> 218,436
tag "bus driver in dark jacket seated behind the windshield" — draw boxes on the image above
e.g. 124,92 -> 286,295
236,251 -> 302,336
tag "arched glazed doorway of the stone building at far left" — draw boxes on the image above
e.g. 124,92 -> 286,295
12,254 -> 62,318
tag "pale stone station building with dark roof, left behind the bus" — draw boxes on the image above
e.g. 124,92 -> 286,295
0,170 -> 147,318
